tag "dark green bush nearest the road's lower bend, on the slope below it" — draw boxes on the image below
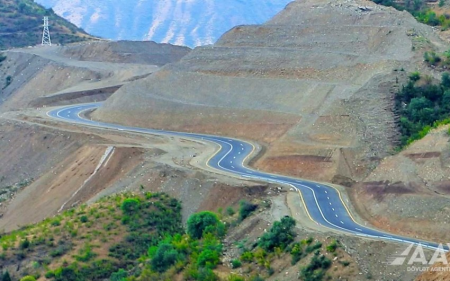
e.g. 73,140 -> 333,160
258,216 -> 295,252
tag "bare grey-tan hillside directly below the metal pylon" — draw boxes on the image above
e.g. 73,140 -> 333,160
0,42 -> 190,111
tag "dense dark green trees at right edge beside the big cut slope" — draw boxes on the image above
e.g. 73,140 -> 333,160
396,72 -> 450,145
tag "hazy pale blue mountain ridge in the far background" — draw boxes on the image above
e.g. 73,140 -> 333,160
31,0 -> 292,47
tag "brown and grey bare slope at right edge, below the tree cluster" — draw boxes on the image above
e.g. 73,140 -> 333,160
351,124 -> 450,242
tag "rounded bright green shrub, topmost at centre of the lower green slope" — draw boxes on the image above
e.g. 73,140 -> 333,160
187,211 -> 225,239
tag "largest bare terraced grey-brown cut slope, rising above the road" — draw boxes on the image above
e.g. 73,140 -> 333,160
94,0 -> 441,182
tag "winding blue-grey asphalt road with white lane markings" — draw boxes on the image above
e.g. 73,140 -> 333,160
47,103 -> 447,250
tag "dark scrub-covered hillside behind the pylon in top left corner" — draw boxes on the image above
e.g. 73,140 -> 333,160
0,0 -> 90,50
